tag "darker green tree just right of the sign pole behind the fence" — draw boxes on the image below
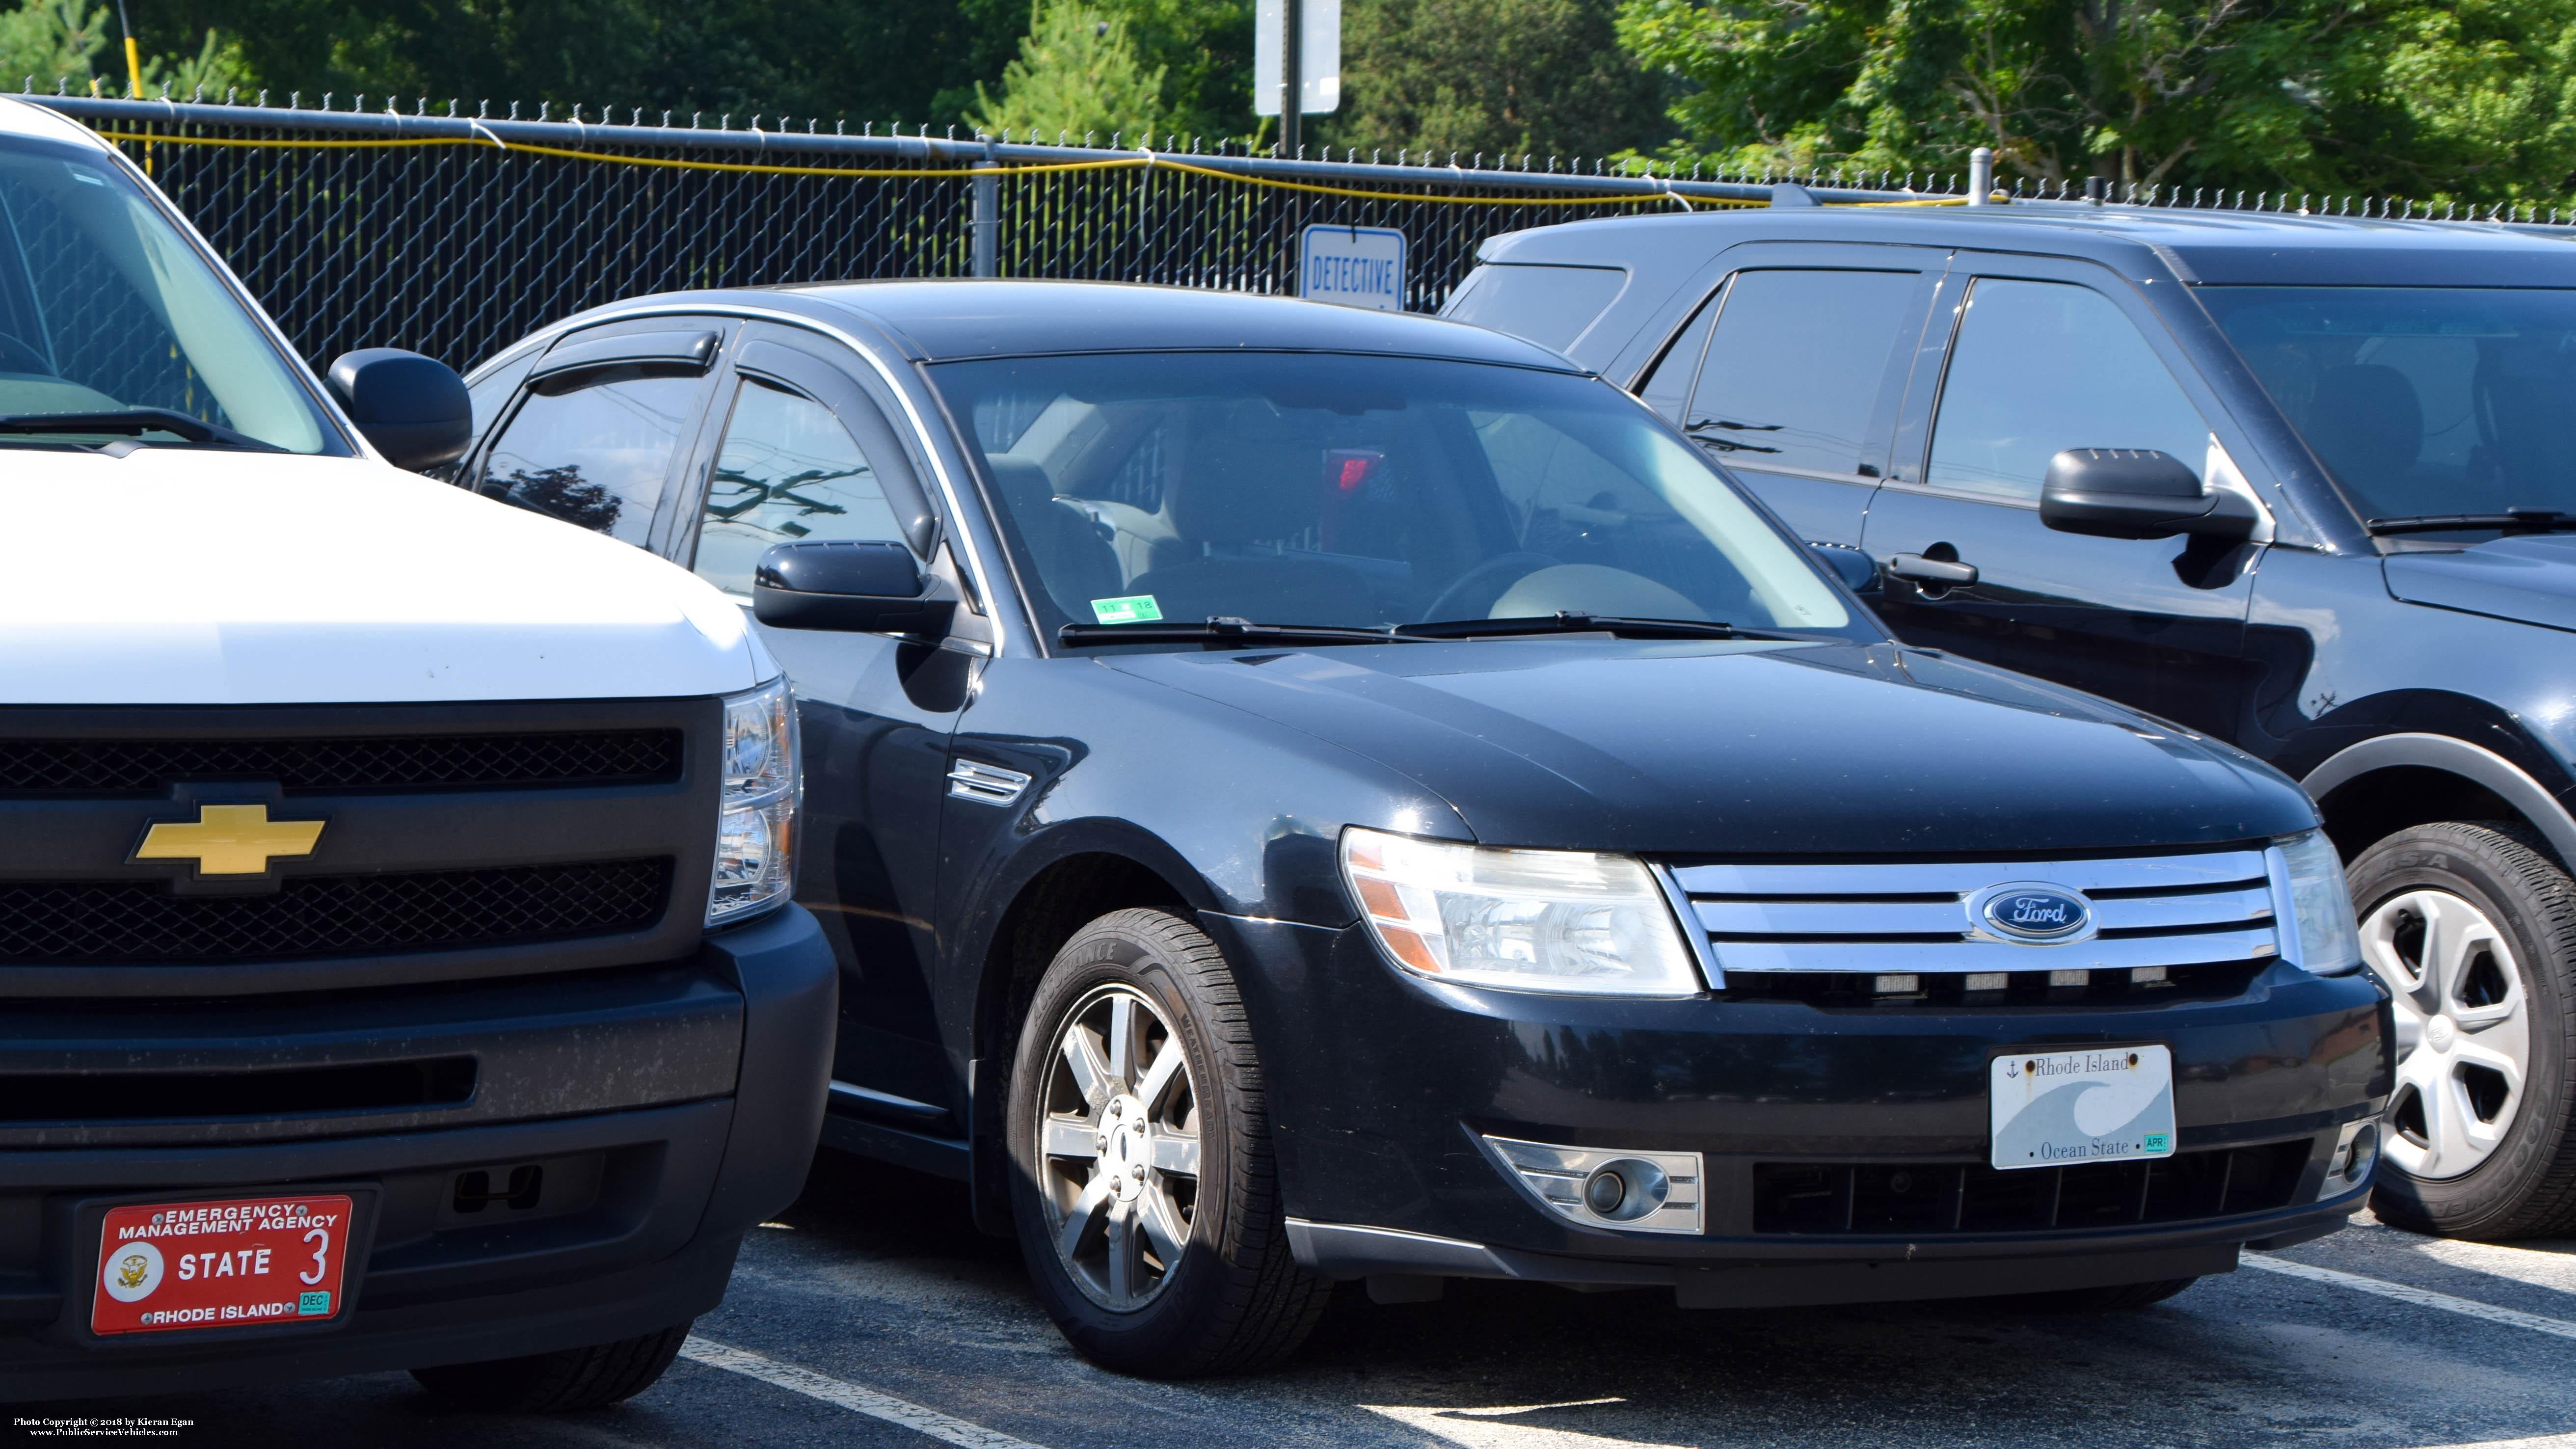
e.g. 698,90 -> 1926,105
1319,0 -> 1669,157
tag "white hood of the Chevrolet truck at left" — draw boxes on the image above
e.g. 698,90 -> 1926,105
0,449 -> 778,704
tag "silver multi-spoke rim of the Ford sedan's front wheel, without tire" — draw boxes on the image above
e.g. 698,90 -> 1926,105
1038,985 -> 1198,1313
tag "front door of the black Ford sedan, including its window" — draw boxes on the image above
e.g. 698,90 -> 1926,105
672,322 -> 981,1137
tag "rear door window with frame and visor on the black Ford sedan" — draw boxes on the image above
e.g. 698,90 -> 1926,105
458,317 -> 734,549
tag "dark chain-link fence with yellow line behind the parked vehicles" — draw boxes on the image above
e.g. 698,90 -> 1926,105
23,80 -> 2576,366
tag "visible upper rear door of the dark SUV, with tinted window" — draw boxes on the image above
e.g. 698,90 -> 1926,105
1638,242 -> 1945,544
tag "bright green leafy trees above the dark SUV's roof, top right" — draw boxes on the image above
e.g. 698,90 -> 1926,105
1620,0 -> 2576,198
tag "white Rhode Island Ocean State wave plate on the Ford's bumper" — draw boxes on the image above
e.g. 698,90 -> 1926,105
1986,1047 -> 2174,1171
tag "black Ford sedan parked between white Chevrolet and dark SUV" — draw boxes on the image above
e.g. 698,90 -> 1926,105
461,281 -> 2388,1374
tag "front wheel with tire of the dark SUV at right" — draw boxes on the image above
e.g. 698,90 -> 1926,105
2349,820 -> 2576,1237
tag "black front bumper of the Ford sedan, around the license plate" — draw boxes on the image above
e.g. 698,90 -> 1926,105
1203,915 -> 2390,1305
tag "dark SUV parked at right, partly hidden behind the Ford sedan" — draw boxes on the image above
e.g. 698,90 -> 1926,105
1445,200 -> 2576,1237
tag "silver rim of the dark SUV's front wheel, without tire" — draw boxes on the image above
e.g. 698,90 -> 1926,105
2362,889 -> 2532,1181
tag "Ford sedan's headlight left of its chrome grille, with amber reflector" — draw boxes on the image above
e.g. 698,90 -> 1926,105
1342,828 -> 1703,995
